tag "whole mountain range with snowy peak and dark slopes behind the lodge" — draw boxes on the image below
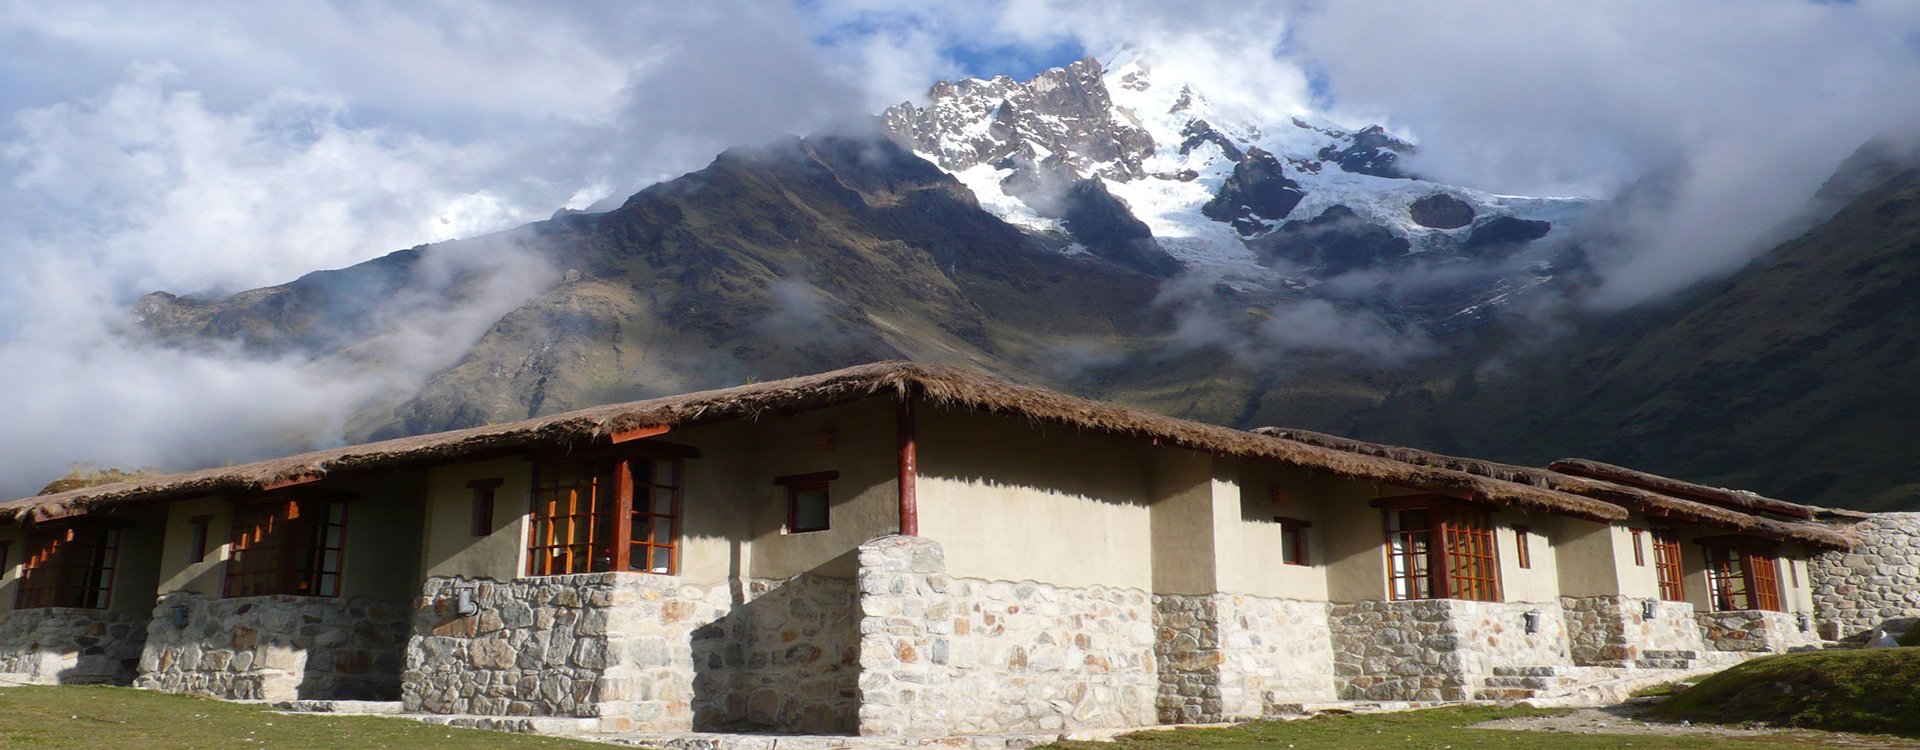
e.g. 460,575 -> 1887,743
93,54 -> 1920,506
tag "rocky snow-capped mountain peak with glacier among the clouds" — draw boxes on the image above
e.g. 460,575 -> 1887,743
879,48 -> 1590,304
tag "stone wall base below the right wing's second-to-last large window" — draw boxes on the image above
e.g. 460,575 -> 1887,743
1561,597 -> 1707,668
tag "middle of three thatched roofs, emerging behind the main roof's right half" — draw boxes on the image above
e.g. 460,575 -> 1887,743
1254,428 -> 1851,549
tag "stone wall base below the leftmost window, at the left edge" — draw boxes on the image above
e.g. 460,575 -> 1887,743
0,606 -> 146,685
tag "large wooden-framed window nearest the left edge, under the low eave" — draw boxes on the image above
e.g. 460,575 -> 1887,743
13,520 -> 119,610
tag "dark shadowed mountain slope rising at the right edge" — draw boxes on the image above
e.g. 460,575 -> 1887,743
1344,161 -> 1920,508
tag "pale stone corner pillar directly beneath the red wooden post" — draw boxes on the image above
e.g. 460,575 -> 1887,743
858,535 -> 952,737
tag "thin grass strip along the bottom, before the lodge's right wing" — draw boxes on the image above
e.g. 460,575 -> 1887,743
1058,706 -> 1912,750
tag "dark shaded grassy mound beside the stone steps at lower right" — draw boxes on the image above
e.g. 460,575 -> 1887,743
1653,648 -> 1920,737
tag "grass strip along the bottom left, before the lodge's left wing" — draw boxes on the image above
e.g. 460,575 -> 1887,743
0,687 -> 605,750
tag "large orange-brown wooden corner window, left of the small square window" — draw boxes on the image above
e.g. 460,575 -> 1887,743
526,457 -> 680,575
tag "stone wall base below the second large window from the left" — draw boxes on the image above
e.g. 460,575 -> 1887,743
134,591 -> 407,700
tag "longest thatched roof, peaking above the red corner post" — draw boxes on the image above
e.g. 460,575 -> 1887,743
0,363 -> 1626,522
